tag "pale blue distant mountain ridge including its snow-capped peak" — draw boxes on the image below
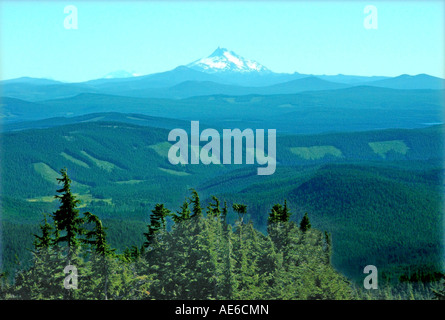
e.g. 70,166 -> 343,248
0,47 -> 445,102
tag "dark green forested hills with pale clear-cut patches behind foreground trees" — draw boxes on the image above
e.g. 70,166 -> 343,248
1,119 -> 443,279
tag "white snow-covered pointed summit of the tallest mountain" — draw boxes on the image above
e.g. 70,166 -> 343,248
187,47 -> 270,73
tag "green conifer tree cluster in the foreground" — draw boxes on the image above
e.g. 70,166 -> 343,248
0,170 -> 440,300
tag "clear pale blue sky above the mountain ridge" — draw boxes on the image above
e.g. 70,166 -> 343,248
0,1 -> 444,82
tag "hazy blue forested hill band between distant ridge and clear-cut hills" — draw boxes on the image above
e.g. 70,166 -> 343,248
0,86 -> 444,134
